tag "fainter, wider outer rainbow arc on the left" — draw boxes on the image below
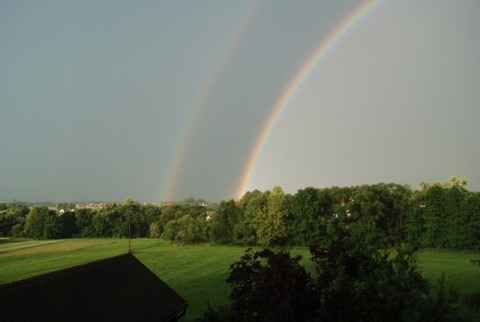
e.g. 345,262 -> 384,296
160,1 -> 263,201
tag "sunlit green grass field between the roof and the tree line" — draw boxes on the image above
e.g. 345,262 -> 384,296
0,239 -> 480,321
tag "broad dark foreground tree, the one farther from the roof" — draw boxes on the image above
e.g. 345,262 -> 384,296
310,238 -> 458,321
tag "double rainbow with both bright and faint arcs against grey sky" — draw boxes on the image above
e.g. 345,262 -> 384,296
161,0 -> 382,201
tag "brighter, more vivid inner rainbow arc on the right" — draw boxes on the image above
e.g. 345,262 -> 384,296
236,0 -> 381,199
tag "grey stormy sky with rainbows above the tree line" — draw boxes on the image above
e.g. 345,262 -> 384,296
0,0 -> 480,202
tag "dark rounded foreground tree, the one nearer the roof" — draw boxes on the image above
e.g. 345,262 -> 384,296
227,249 -> 315,321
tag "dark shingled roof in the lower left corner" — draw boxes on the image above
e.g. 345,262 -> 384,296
0,254 -> 187,321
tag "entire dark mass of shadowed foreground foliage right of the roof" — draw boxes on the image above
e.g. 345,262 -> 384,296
200,238 -> 460,321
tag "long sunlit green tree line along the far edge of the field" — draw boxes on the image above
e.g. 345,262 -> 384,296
0,177 -> 480,248
